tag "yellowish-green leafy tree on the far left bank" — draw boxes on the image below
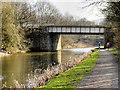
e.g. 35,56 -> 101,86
2,3 -> 28,52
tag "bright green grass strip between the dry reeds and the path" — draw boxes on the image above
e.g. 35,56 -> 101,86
36,51 -> 99,89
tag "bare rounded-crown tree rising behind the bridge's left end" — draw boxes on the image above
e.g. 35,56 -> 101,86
33,1 -> 61,25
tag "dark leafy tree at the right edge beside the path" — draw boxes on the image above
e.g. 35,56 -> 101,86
103,1 -> 120,50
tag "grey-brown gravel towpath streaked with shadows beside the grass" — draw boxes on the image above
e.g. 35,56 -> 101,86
77,50 -> 118,88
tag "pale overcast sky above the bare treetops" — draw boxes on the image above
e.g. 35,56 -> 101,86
49,0 -> 104,21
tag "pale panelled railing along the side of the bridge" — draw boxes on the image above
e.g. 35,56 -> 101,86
47,26 -> 105,33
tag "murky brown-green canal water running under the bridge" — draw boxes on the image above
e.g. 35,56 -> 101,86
0,48 -> 93,87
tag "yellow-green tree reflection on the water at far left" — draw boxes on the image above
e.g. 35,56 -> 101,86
2,54 -> 32,86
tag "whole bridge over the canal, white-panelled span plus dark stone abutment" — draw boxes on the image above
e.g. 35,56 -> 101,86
27,25 -> 110,51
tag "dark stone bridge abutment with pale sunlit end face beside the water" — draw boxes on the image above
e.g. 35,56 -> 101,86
28,29 -> 61,52
